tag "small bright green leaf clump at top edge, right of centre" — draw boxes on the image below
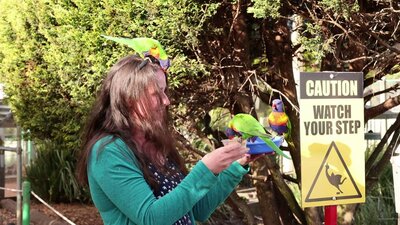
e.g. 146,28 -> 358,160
247,0 -> 281,18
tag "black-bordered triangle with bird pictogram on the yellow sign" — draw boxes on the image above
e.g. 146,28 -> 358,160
305,141 -> 362,202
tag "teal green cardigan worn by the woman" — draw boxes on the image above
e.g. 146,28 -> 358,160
88,136 -> 248,225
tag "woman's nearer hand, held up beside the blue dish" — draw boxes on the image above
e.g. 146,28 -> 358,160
201,142 -> 248,174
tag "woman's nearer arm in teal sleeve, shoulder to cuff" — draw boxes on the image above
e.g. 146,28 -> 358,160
88,141 -> 218,225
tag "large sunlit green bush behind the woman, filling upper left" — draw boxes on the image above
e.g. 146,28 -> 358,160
0,0 -> 219,200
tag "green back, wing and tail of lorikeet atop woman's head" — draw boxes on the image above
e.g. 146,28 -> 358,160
101,35 -> 168,60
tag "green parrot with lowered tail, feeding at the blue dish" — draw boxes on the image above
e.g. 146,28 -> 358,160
226,113 -> 291,159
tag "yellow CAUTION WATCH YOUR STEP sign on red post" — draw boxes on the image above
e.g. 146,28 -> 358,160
300,72 -> 365,207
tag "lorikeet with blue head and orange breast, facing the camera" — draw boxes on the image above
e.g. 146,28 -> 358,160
268,99 -> 291,136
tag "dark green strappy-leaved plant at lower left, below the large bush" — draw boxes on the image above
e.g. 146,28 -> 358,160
26,141 -> 90,202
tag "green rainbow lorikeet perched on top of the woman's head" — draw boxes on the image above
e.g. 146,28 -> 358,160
101,35 -> 171,71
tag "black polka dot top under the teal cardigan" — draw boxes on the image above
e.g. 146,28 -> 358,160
148,161 -> 192,225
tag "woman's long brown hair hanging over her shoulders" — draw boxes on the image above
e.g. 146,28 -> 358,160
77,55 -> 187,189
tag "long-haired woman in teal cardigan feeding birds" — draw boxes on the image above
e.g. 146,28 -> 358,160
78,55 -> 250,225
